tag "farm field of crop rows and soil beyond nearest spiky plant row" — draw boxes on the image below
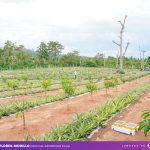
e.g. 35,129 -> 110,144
0,67 -> 150,141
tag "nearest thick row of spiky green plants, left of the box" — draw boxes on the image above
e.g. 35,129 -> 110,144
26,84 -> 150,141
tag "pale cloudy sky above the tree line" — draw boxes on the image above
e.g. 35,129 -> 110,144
0,0 -> 150,57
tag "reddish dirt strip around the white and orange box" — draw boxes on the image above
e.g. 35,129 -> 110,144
90,90 -> 150,141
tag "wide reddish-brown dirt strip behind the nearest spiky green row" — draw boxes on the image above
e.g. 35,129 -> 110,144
0,76 -> 150,141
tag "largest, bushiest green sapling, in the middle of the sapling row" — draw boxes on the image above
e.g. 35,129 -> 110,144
61,77 -> 75,111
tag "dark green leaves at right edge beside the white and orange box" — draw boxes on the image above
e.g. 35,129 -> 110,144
138,110 -> 150,136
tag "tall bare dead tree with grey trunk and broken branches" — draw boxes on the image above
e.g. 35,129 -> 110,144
112,15 -> 130,73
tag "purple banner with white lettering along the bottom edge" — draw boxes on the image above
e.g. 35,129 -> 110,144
0,141 -> 150,150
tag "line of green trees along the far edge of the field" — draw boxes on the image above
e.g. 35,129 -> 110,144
0,41 -> 150,70
